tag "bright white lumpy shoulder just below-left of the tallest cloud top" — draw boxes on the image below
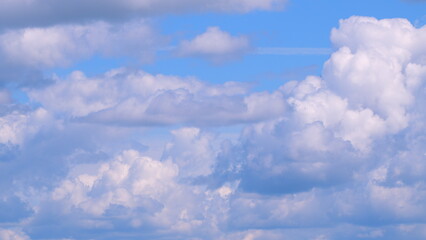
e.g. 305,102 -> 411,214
284,77 -> 387,151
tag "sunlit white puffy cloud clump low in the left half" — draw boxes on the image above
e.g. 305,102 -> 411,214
52,151 -> 178,215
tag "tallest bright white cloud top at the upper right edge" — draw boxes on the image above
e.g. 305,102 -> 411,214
323,17 -> 426,132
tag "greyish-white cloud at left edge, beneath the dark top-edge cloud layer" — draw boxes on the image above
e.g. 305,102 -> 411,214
0,21 -> 166,88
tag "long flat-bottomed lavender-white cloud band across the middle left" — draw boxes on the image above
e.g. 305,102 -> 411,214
29,69 -> 285,126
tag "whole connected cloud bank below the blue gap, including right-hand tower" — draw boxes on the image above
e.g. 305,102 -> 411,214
0,17 -> 426,240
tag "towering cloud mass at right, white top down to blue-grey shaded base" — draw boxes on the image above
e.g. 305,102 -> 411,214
209,17 -> 426,235
